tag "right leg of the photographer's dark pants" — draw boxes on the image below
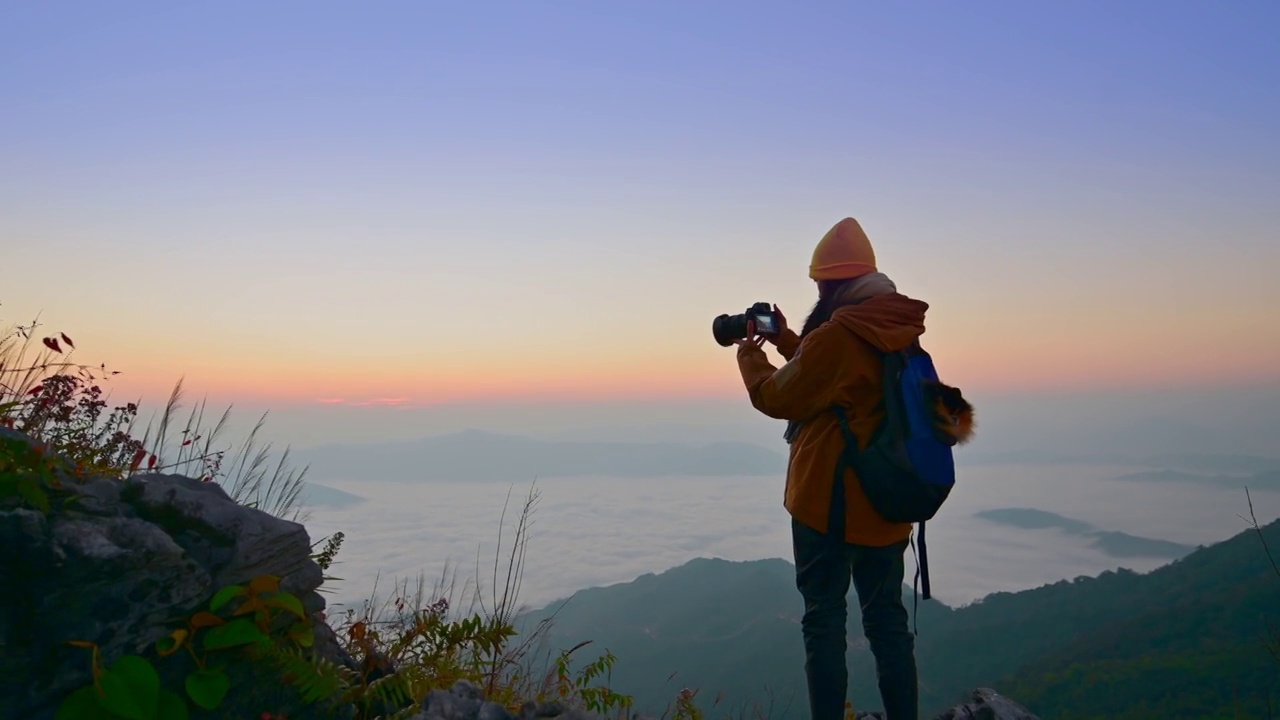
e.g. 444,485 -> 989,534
852,541 -> 919,720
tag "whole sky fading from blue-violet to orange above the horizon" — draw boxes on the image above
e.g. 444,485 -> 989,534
0,0 -> 1280,438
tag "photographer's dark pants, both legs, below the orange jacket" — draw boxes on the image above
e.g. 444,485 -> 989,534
791,520 -> 919,720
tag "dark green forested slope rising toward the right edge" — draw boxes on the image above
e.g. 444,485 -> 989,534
919,521 -> 1280,717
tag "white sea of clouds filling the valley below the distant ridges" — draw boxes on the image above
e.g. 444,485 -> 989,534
306,464 -> 1280,617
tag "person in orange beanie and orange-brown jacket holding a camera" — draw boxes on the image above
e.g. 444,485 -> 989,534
732,218 -> 928,720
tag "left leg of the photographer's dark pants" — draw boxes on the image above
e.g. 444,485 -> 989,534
791,520 -> 850,720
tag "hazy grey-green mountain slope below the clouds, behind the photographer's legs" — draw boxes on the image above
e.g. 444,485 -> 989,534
529,559 -> 972,720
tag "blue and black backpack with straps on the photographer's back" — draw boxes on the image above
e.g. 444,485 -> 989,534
828,342 -> 972,600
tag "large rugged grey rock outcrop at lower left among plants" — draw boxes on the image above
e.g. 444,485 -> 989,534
0,430 -> 347,720
